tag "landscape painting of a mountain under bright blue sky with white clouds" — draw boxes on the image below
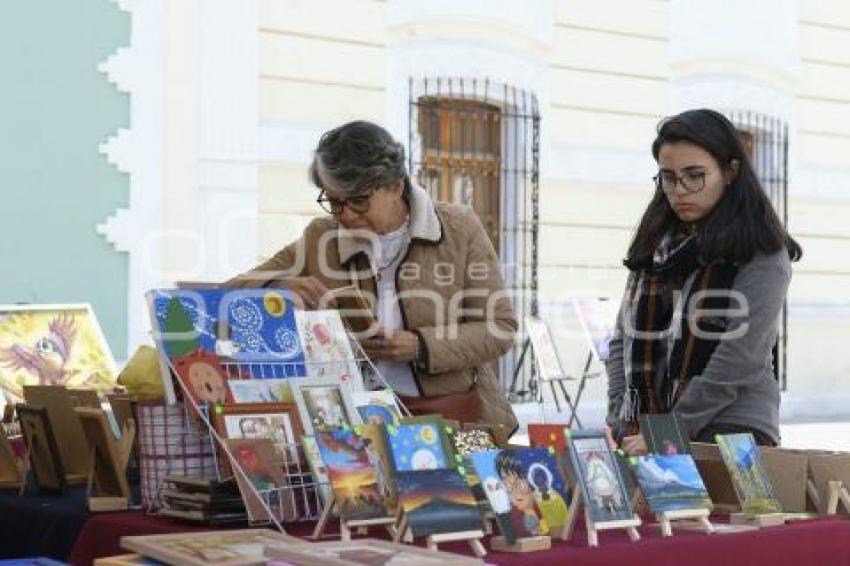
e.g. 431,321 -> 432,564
629,454 -> 712,515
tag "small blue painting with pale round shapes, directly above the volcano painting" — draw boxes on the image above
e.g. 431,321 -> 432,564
386,422 -> 453,472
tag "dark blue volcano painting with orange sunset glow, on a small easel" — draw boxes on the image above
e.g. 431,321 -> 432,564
396,469 -> 482,537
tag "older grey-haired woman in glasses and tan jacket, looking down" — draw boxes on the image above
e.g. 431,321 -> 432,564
225,122 -> 517,446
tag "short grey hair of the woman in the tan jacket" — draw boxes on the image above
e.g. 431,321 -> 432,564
308,121 -> 410,198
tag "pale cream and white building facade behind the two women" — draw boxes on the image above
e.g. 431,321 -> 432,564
106,0 -> 850,422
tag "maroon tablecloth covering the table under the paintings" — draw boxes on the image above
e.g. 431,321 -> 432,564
69,512 -> 850,566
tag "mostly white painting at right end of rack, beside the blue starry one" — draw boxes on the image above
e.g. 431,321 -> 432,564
295,310 -> 363,389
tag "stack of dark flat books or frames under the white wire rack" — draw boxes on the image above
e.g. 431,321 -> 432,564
159,476 -> 248,525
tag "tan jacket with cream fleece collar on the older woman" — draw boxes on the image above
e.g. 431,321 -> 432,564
224,187 -> 517,436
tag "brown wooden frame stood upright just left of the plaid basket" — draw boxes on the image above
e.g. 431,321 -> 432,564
74,407 -> 130,506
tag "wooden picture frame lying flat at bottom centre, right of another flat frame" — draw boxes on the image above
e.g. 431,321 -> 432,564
266,539 -> 484,566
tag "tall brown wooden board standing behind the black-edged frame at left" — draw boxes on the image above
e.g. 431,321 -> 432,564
24,385 -> 89,485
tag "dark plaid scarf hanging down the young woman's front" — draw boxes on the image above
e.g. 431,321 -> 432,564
621,234 -> 738,440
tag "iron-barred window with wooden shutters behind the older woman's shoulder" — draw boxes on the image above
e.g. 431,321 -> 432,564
408,78 -> 540,400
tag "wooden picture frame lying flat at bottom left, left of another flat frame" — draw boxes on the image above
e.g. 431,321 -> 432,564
121,529 -> 296,566
